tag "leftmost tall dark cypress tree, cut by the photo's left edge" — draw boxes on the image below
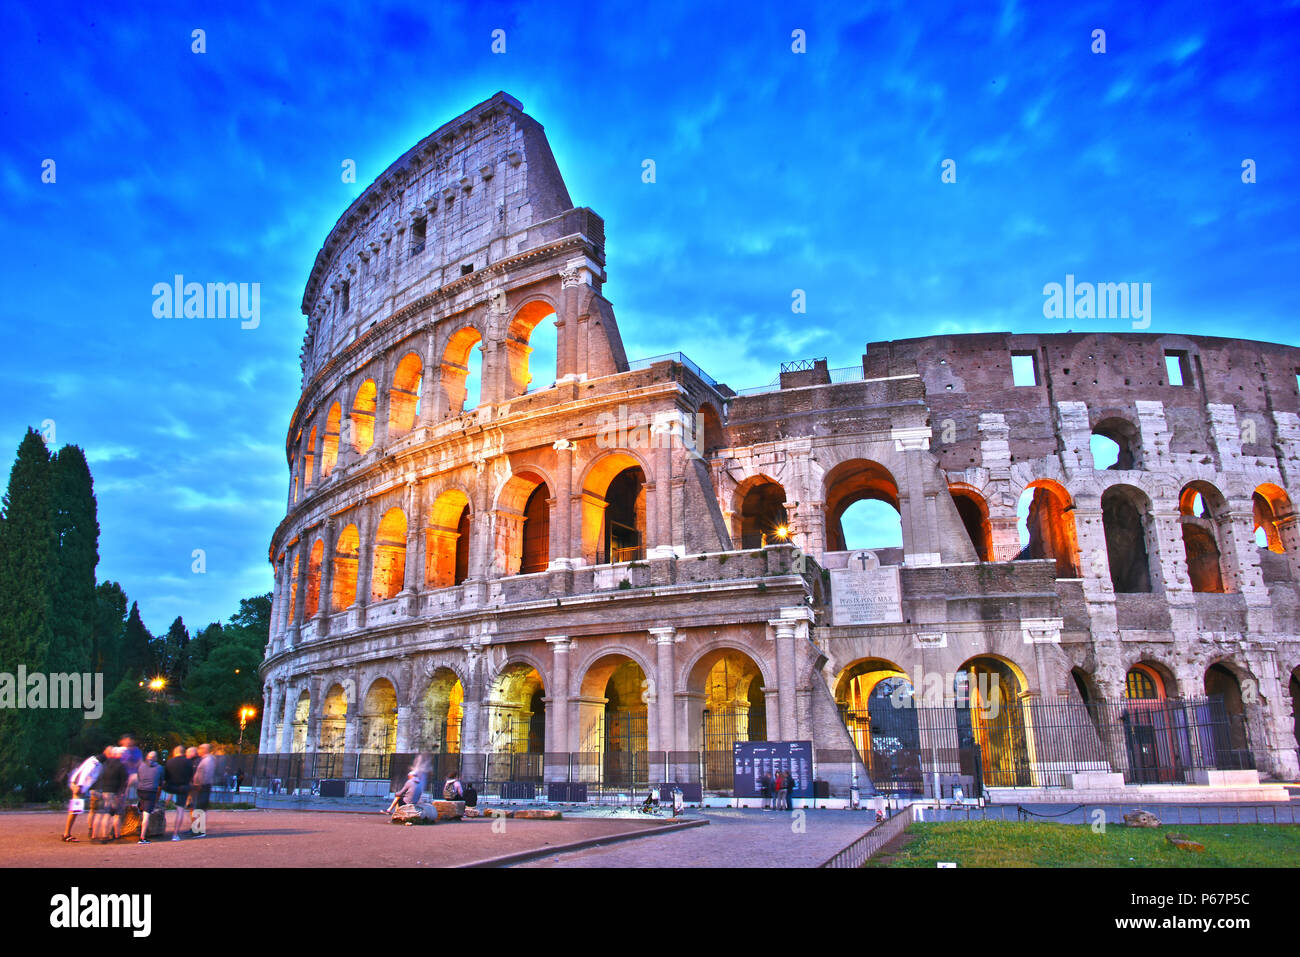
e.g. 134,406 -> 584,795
0,429 -> 59,796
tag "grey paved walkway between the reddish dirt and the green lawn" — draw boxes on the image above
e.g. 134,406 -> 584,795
515,809 -> 872,867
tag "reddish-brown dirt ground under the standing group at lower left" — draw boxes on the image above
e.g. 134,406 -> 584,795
0,810 -> 659,867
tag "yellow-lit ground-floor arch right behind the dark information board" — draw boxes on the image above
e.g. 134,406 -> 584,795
696,649 -> 768,791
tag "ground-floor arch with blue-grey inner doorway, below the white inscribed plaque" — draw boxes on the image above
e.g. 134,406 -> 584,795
835,658 -> 924,794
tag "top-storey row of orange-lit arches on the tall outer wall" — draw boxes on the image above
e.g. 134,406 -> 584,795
290,299 -> 558,505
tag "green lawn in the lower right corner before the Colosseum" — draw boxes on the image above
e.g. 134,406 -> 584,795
867,820 -> 1300,867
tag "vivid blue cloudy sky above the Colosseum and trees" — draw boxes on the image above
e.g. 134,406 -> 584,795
0,3 -> 1300,631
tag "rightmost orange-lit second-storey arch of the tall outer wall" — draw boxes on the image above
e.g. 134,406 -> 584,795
582,452 -> 646,564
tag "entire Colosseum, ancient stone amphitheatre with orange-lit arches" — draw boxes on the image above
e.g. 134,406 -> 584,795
260,94 -> 1300,801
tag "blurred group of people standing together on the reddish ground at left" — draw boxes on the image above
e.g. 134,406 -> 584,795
64,735 -> 220,844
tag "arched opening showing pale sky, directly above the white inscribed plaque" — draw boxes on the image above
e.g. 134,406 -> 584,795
826,459 -> 902,548
